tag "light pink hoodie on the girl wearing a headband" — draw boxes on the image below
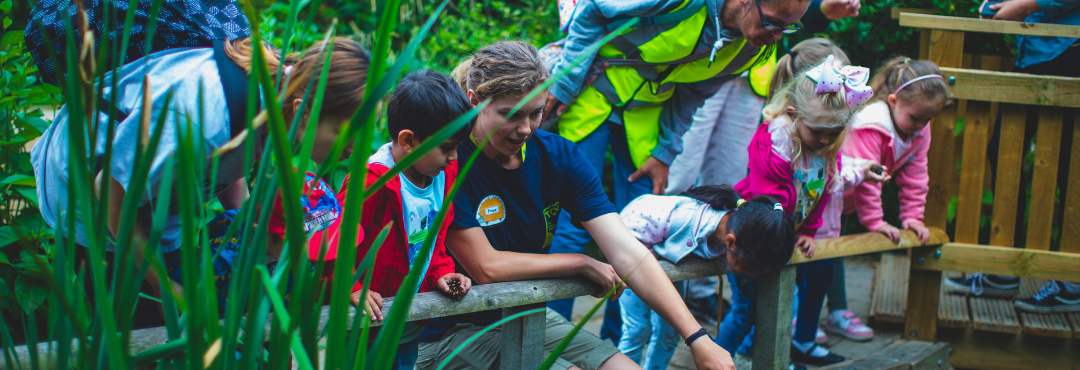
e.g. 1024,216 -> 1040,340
842,100 -> 930,231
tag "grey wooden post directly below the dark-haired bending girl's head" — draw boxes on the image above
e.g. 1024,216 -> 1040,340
753,265 -> 795,370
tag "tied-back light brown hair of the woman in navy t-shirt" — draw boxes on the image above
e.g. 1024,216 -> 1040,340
450,41 -> 551,99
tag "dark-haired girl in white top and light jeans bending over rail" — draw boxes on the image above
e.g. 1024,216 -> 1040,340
619,184 -> 795,369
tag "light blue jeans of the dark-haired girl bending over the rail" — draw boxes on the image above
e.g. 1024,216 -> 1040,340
619,282 -> 686,370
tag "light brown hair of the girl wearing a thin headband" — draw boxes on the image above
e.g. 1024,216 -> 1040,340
870,56 -> 948,107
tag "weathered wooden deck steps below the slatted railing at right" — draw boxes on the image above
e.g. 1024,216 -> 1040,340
869,253 -> 1080,339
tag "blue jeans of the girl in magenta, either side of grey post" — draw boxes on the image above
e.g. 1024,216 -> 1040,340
716,260 -> 833,354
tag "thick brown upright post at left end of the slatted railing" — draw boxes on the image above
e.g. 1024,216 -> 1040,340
903,29 -> 963,342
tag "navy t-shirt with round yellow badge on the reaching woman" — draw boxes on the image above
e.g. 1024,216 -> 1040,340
420,131 -> 616,342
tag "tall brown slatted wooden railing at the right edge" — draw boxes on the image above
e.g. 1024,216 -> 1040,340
899,12 -> 1080,368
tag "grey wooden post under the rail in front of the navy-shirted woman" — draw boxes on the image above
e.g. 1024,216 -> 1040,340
499,302 -> 548,370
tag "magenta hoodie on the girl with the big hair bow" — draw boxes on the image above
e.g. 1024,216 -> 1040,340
734,119 -> 840,237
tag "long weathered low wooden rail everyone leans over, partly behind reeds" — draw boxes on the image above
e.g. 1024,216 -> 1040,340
0,228 -> 948,370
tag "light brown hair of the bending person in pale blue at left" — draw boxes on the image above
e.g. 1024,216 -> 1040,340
225,38 -> 372,119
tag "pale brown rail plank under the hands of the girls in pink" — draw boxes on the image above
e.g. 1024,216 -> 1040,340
791,228 -> 949,264
